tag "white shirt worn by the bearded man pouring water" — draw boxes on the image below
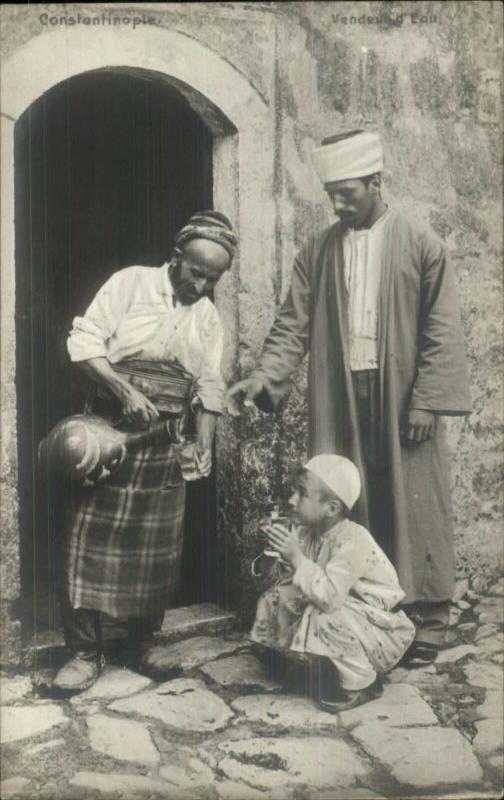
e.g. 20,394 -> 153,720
67,264 -> 224,412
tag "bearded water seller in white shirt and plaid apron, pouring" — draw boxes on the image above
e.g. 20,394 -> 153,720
54,211 -> 236,691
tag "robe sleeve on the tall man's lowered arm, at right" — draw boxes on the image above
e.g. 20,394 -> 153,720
409,231 -> 471,415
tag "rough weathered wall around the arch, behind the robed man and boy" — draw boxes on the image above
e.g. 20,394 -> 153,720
2,2 -> 503,644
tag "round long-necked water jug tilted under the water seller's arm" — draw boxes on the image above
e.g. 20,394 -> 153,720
38,414 -> 180,486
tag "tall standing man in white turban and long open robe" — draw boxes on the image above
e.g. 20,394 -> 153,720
228,130 -> 471,666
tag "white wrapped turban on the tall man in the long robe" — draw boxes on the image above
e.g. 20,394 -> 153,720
312,131 -> 383,184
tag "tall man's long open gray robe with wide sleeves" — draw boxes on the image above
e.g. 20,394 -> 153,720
254,210 -> 471,603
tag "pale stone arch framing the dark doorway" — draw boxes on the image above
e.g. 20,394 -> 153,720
0,28 -> 275,661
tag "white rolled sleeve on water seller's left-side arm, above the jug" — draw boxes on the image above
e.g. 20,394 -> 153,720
67,273 -> 127,361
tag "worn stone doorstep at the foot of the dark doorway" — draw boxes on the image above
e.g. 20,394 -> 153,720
23,603 -> 236,670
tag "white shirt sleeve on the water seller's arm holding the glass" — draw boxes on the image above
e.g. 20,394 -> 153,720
193,302 -> 225,414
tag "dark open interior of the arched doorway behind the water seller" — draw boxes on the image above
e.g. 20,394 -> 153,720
15,71 -> 234,644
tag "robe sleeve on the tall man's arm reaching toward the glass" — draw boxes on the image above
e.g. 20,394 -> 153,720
251,243 -> 311,411
